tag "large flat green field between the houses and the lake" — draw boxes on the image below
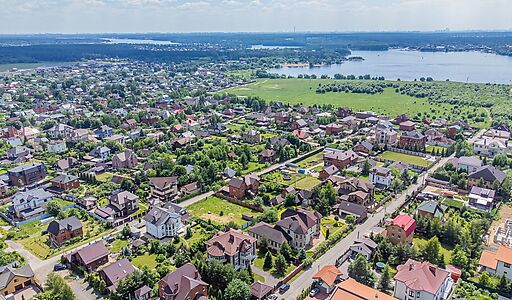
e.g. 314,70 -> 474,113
223,78 -> 487,127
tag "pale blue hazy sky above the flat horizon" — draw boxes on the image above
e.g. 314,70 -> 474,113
0,0 -> 512,34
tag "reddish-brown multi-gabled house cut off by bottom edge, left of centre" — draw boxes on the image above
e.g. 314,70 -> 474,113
158,263 -> 208,300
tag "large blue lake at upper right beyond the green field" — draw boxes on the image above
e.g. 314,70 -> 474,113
268,49 -> 512,84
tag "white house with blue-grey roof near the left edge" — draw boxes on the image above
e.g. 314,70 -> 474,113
9,188 -> 55,220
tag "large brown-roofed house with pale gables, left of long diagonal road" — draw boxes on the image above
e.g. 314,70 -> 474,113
276,208 -> 322,249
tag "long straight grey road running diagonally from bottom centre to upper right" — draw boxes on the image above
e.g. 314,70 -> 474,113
280,155 -> 453,299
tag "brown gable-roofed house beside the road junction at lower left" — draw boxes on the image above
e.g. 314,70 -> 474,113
63,241 -> 110,272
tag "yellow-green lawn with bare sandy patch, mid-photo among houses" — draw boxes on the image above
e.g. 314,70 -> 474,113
187,197 -> 261,225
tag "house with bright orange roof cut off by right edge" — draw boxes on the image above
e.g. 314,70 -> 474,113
478,245 -> 512,280
